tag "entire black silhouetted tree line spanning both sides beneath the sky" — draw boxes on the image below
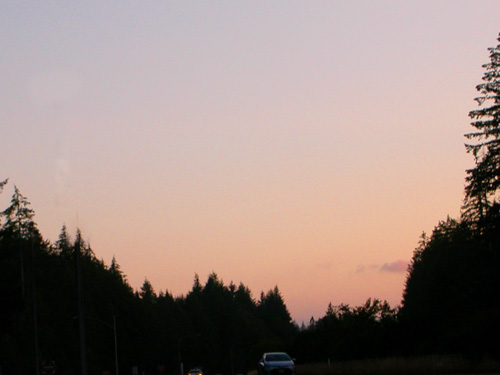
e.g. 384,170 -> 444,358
0,30 -> 500,375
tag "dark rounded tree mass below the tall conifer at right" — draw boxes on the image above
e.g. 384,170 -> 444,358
400,216 -> 500,355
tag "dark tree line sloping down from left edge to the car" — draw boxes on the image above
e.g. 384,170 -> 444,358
0,186 -> 297,374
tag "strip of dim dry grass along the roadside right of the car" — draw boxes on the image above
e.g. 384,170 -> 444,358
297,356 -> 500,375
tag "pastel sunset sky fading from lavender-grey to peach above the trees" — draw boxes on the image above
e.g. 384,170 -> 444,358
0,0 -> 500,323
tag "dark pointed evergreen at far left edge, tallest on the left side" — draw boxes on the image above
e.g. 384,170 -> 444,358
0,181 -> 49,372
